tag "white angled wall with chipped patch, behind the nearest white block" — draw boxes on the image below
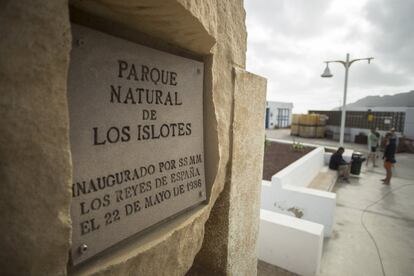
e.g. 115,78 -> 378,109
261,147 -> 336,237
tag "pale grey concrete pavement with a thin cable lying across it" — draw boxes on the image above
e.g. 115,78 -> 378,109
259,130 -> 414,276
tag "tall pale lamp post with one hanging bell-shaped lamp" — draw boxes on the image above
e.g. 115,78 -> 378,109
321,53 -> 374,147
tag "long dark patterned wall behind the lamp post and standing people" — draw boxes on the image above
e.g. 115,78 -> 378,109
309,107 -> 414,142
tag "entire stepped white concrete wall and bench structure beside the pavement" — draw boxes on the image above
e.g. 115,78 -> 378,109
258,143 -> 352,275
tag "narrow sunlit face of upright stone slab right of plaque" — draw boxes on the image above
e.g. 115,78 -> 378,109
227,68 -> 266,276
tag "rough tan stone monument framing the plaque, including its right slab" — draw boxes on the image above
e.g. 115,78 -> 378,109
0,0 -> 265,275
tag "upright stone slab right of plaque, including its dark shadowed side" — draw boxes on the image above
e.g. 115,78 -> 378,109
194,68 -> 266,276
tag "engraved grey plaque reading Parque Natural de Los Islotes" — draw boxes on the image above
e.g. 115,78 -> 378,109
68,25 -> 206,264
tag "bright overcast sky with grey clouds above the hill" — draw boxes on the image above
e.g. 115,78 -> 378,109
245,0 -> 414,113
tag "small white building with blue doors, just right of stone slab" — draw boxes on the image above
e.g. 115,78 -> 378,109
265,101 -> 293,128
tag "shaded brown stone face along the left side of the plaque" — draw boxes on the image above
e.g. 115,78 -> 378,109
0,0 -> 71,275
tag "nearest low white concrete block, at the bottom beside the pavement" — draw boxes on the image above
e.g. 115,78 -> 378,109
258,209 -> 323,276
